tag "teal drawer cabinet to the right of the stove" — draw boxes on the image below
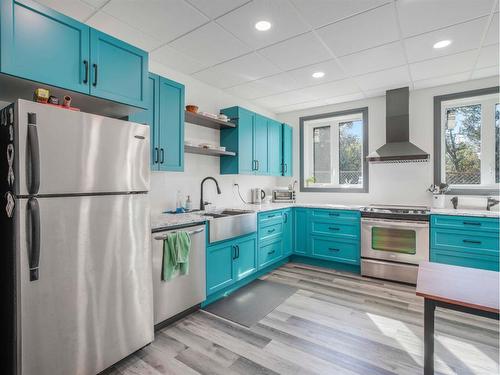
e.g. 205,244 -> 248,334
430,215 -> 500,271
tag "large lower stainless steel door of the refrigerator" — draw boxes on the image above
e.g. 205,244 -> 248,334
16,194 -> 153,375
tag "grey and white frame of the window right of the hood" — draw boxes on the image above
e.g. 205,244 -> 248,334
434,86 -> 500,195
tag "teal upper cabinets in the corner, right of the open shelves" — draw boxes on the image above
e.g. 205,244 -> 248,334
220,107 -> 292,176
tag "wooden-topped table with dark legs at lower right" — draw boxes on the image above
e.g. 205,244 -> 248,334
417,262 -> 500,375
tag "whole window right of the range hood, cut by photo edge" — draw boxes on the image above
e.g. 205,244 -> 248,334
434,87 -> 500,194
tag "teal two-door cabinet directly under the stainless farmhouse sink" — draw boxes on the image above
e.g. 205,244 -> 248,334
206,233 -> 257,296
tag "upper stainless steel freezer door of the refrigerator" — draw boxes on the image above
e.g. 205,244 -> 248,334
15,100 -> 150,196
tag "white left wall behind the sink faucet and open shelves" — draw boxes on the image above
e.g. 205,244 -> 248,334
149,61 -> 277,214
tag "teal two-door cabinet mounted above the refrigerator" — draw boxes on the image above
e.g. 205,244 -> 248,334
0,0 -> 148,108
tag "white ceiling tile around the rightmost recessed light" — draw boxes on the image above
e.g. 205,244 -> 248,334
404,17 -> 488,63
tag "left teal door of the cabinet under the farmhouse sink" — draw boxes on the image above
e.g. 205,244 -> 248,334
207,241 -> 236,295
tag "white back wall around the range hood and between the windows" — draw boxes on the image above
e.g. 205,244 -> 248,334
278,77 -> 498,205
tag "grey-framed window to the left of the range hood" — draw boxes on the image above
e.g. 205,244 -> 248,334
300,108 -> 368,192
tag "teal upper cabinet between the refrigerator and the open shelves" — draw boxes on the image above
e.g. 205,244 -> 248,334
129,73 -> 184,172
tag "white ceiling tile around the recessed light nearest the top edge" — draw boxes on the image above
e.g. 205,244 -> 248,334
217,0 -> 309,49
